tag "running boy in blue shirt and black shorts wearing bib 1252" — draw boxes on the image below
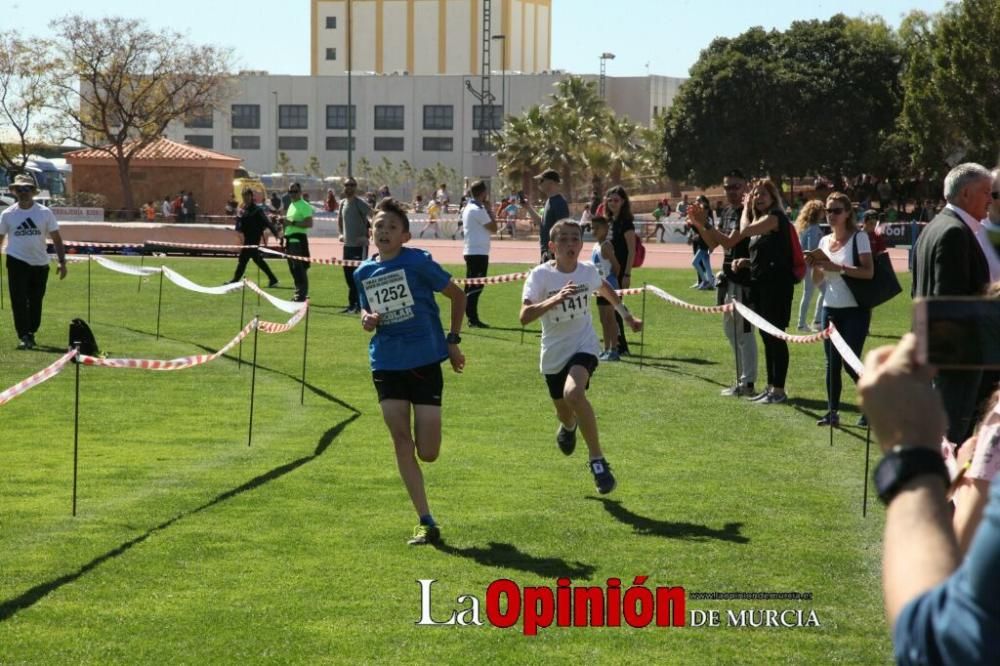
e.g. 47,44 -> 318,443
354,199 -> 465,546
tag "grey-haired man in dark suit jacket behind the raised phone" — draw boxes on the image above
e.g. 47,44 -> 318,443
913,163 -> 993,445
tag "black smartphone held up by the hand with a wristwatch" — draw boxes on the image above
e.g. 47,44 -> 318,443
913,297 -> 1000,370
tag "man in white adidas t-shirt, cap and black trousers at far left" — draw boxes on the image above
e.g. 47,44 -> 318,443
0,175 -> 66,349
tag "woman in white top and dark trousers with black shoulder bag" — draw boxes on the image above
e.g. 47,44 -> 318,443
806,192 -> 875,426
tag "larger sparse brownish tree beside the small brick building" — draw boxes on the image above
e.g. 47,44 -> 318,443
49,16 -> 232,210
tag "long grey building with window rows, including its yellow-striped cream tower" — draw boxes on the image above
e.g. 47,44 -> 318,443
167,0 -> 684,177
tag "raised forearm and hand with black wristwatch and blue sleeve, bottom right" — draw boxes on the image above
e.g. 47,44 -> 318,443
858,333 -> 1000,666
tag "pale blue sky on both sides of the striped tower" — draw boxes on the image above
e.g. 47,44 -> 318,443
29,0 -> 945,76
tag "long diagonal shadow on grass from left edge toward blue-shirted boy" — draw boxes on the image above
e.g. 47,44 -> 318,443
0,414 -> 360,622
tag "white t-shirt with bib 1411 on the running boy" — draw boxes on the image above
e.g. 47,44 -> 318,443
521,261 -> 603,375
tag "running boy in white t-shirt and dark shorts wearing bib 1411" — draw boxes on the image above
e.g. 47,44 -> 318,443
520,220 -> 642,495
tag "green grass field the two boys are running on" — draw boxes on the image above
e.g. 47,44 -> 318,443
0,253 -> 909,664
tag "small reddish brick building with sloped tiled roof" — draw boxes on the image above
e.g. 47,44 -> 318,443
66,138 -> 242,216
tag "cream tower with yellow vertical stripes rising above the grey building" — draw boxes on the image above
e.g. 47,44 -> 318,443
310,0 -> 552,76
